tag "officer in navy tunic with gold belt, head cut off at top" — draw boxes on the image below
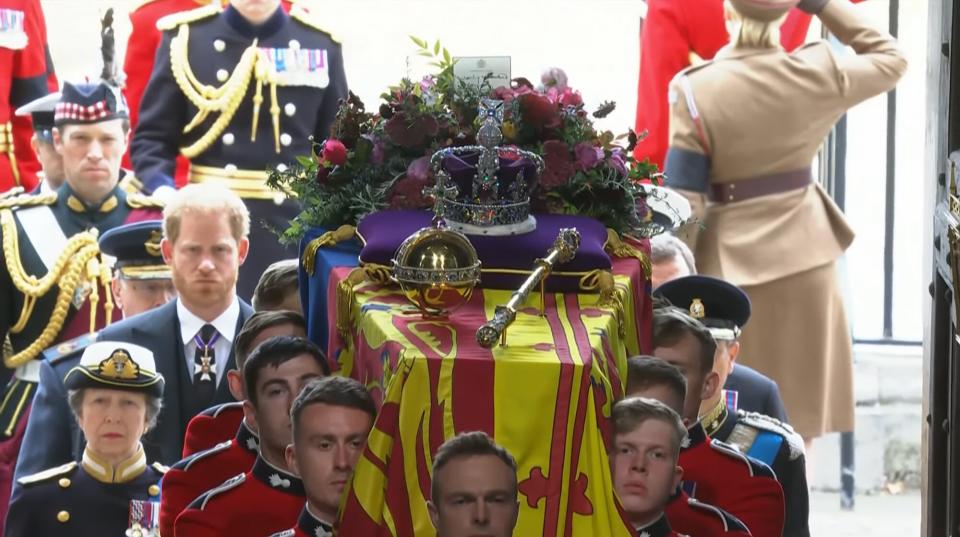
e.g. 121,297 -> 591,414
131,0 -> 347,298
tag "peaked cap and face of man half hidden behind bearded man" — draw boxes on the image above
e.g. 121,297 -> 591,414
99,220 -> 177,318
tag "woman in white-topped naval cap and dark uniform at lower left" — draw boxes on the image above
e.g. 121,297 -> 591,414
5,341 -> 166,537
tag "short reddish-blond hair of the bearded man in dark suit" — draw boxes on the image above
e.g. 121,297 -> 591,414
163,183 -> 250,242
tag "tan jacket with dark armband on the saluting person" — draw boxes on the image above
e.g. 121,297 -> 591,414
665,0 -> 907,286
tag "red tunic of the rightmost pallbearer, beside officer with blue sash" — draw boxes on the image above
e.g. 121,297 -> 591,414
679,422 -> 785,536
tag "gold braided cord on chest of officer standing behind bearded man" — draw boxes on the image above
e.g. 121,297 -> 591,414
170,24 -> 259,159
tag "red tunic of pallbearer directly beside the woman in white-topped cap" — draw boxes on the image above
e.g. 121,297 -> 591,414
160,418 -> 259,535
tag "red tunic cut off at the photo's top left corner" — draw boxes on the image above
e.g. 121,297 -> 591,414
0,0 -> 59,192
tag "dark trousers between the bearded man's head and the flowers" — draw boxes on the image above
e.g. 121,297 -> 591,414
237,199 -> 300,301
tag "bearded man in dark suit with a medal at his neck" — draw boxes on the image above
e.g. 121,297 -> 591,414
16,181 -> 253,482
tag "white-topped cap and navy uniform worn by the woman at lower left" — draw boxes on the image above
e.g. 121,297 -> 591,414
4,341 -> 166,537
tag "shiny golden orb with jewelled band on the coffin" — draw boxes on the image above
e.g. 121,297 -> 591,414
393,222 -> 480,317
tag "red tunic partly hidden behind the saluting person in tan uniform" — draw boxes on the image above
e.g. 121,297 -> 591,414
634,0 -> 824,169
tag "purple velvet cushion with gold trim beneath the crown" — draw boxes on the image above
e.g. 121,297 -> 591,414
357,211 -> 611,292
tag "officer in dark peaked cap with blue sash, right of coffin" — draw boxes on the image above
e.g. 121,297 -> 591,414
656,275 -> 810,537
